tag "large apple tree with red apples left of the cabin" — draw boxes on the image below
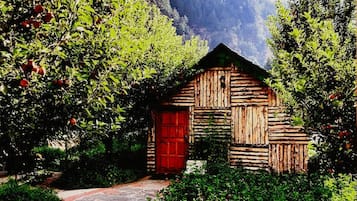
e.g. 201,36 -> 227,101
0,0 -> 207,172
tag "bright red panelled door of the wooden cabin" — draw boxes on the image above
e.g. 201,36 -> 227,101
156,110 -> 188,173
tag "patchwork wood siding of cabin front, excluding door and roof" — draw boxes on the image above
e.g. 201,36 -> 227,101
148,67 -> 309,172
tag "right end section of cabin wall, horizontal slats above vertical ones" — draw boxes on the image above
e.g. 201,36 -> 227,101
268,89 -> 310,173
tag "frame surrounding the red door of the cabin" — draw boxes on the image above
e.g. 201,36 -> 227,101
154,106 -> 190,174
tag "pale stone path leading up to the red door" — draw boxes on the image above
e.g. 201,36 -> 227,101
58,177 -> 170,201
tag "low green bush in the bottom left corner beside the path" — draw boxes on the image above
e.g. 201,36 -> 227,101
0,180 -> 60,201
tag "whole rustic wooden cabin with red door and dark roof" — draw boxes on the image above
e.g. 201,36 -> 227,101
147,44 -> 309,173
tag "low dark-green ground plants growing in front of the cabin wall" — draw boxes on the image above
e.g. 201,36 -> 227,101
159,167 -> 331,201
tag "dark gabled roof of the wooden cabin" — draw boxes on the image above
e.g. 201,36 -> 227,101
194,43 -> 270,81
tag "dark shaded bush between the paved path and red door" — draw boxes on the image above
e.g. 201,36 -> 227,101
53,140 -> 146,189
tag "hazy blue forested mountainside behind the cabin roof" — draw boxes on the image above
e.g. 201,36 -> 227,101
149,0 -> 275,66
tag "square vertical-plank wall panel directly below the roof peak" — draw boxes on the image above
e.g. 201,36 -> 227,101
195,68 -> 231,107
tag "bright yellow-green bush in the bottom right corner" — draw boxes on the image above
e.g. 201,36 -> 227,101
324,174 -> 357,201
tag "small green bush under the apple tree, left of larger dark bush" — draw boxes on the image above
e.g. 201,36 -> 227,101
32,146 -> 66,171
